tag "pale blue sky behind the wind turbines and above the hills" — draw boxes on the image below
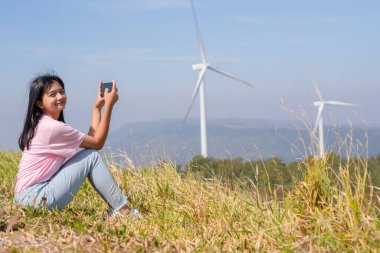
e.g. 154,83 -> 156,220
0,0 -> 380,148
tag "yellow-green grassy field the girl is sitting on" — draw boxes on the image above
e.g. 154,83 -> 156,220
0,152 -> 380,252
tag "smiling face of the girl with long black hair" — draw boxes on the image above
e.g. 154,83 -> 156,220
37,82 -> 67,120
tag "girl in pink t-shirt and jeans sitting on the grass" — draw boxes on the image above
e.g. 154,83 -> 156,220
15,74 -> 131,215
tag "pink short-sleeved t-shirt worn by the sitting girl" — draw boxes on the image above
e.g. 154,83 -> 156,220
15,115 -> 86,195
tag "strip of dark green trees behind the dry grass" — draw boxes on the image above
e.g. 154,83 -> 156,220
185,153 -> 380,190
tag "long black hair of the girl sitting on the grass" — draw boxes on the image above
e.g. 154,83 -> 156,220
18,74 -> 65,150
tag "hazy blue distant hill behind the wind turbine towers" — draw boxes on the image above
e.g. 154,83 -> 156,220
108,119 -> 380,164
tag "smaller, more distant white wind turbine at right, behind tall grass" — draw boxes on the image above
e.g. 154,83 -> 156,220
313,83 -> 357,157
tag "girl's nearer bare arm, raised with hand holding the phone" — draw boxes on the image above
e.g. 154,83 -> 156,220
80,81 -> 118,149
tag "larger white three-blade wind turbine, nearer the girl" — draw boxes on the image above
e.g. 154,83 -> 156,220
184,0 -> 253,157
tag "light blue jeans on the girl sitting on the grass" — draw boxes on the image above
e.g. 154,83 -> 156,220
15,149 -> 127,211
